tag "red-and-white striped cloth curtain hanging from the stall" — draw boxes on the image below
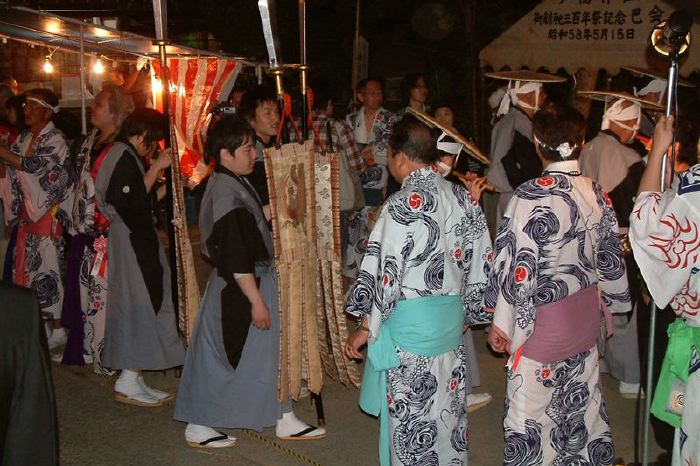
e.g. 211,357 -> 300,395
151,58 -> 241,185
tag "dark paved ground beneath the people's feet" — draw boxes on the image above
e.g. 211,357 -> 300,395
53,226 -> 659,466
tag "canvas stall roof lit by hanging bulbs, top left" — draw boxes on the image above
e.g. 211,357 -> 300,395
0,2 -> 256,65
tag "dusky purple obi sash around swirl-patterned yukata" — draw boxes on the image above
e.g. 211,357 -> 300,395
519,285 -> 612,364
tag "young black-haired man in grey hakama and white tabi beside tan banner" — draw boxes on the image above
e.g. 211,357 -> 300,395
174,116 -> 326,448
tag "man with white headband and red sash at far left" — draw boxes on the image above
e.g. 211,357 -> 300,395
0,89 -> 72,348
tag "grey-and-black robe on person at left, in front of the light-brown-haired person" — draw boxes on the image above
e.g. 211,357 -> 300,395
95,142 -> 185,370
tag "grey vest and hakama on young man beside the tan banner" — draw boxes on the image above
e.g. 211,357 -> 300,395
173,167 -> 291,431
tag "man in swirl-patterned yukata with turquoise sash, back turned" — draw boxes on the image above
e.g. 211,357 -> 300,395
345,117 -> 491,466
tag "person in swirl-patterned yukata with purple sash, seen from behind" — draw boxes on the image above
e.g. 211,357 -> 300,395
484,106 -> 631,466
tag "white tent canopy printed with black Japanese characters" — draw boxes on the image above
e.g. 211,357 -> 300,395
479,0 -> 700,74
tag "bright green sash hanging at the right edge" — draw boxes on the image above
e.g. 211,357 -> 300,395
651,318 -> 700,428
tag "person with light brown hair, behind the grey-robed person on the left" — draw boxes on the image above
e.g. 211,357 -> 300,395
63,86 -> 134,374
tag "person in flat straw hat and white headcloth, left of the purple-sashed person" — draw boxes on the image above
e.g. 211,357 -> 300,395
486,70 -> 565,219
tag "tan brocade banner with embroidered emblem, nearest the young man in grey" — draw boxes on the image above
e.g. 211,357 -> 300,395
264,141 -> 323,400
